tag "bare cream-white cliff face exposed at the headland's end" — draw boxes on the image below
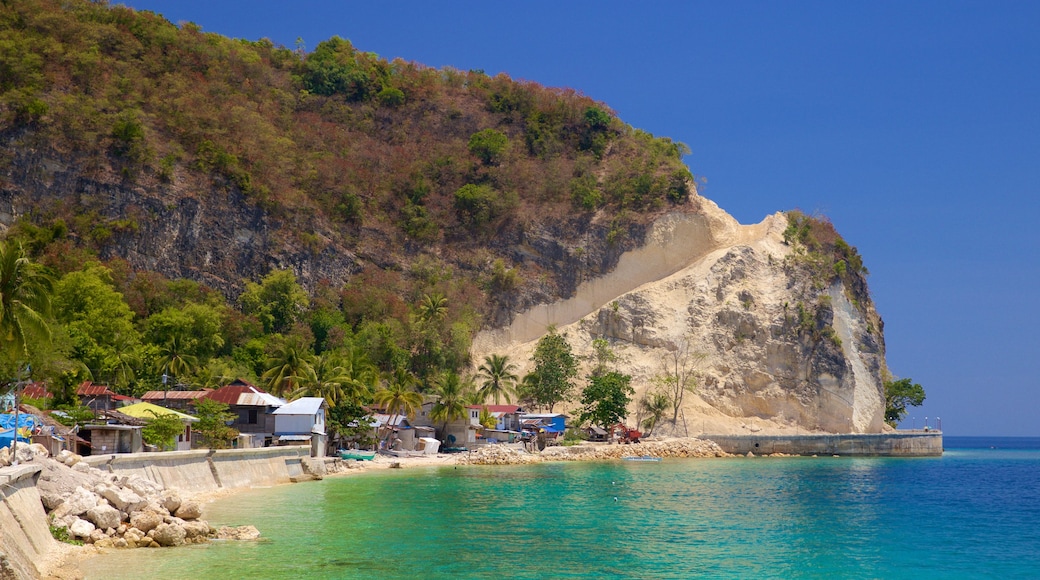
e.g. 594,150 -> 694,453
473,201 -> 884,434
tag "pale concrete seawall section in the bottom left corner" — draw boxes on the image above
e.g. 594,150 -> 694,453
0,464 -> 59,578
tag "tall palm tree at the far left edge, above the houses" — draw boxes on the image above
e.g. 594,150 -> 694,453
0,241 -> 54,362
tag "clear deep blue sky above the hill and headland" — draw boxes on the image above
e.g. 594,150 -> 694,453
113,0 -> 1040,437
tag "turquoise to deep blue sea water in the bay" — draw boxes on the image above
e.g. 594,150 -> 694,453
82,437 -> 1040,580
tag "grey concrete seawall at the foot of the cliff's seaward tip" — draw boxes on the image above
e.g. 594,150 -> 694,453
698,431 -> 942,457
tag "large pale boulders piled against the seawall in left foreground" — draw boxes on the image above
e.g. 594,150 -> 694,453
10,445 -> 260,548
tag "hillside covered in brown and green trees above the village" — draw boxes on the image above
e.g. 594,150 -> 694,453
0,0 -> 696,428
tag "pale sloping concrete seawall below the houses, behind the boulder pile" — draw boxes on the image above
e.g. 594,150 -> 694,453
83,446 -> 310,492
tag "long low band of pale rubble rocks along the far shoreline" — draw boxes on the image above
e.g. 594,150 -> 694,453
457,438 -> 729,466
